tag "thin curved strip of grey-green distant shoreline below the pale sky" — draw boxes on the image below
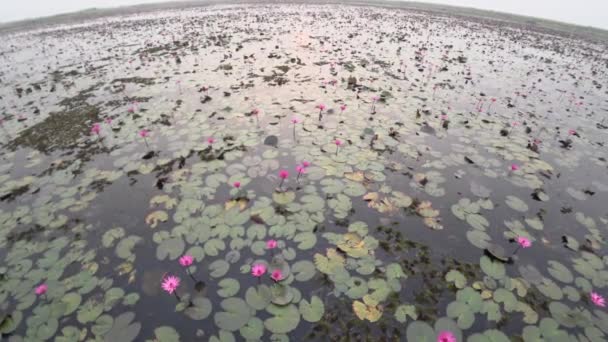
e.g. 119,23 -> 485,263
0,0 -> 608,44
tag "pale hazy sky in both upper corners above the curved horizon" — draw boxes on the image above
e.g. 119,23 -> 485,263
0,0 -> 608,29
